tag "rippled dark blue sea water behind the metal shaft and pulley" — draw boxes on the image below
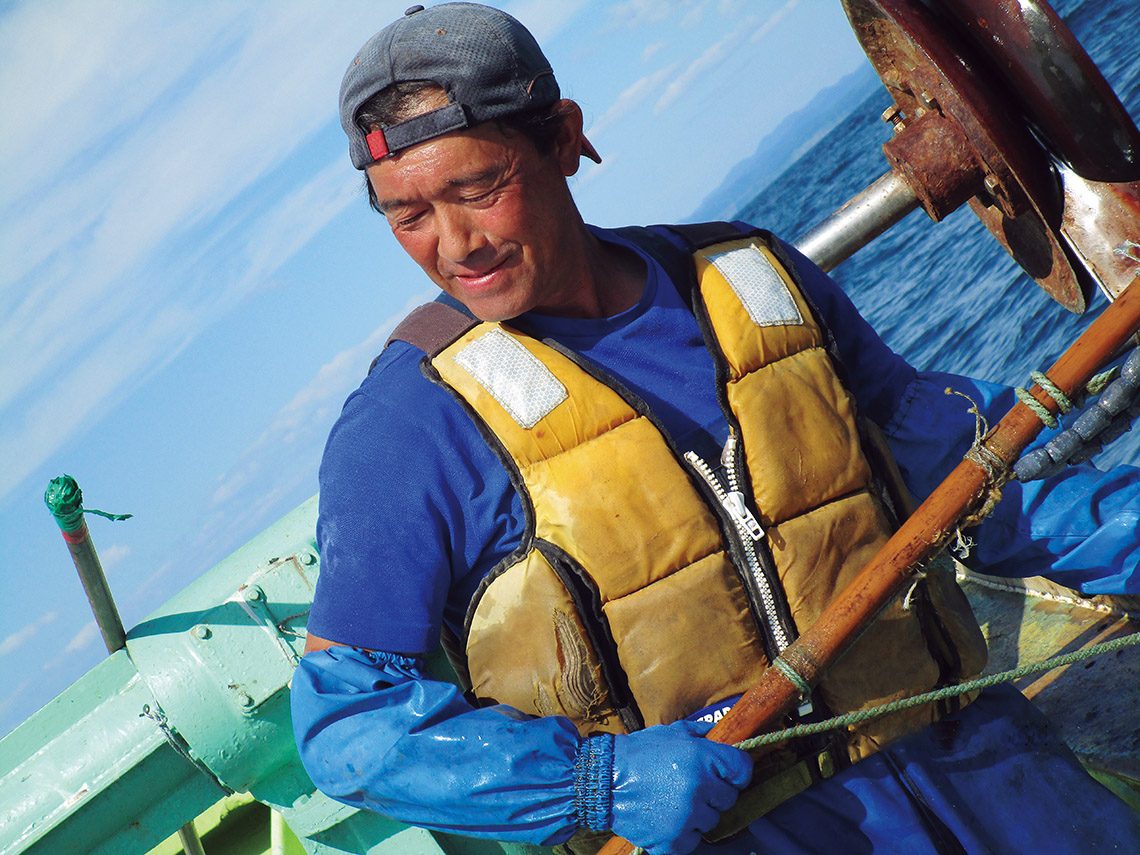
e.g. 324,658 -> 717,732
739,0 -> 1140,466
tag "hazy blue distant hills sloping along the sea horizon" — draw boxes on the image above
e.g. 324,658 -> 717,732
689,63 -> 880,222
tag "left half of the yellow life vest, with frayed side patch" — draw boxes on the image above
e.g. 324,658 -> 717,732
432,324 -> 766,733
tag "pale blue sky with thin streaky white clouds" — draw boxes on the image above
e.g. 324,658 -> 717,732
0,0 -> 865,734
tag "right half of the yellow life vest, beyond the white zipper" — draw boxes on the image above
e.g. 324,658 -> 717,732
695,232 -> 985,760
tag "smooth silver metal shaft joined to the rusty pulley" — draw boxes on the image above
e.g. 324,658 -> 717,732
795,171 -> 919,270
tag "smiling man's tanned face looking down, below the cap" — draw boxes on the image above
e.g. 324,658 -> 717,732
367,114 -> 580,320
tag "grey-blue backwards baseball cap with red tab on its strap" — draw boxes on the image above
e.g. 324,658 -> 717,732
341,3 -> 602,170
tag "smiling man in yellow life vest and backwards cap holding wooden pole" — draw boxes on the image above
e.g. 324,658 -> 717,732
293,3 -> 1140,855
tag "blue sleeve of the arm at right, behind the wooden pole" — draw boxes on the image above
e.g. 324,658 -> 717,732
783,234 -> 1140,595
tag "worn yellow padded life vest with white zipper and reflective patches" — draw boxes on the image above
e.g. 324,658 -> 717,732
430,228 -> 985,760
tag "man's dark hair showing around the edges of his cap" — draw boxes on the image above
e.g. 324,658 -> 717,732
356,80 -> 565,213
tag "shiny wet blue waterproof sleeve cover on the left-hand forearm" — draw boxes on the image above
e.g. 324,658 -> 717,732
292,646 -> 581,846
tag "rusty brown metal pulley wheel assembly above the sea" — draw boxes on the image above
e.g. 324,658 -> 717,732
842,0 -> 1140,312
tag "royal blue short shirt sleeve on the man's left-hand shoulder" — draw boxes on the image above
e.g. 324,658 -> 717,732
309,342 -> 524,653
